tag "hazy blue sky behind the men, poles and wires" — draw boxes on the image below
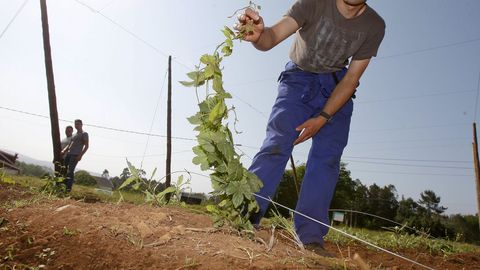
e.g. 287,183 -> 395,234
0,0 -> 480,213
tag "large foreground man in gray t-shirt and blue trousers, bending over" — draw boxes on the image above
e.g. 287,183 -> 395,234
236,0 -> 385,255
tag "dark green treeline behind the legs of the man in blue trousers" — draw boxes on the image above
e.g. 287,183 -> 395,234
273,163 -> 480,244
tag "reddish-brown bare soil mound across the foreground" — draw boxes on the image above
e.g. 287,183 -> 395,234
0,178 -> 480,269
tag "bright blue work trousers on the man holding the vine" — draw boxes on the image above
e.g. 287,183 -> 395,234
249,62 -> 353,245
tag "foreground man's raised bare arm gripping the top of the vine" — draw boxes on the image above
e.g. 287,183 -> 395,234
235,8 -> 300,51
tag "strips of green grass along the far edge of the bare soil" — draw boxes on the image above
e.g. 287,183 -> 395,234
0,173 -> 480,256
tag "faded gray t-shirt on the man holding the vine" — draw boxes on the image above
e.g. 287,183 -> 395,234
286,0 -> 385,73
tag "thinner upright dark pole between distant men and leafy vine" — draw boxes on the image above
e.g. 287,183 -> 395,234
165,56 -> 172,202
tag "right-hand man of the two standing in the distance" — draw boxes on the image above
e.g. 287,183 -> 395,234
64,119 -> 89,192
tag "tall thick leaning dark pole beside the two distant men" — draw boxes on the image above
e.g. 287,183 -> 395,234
40,0 -> 62,174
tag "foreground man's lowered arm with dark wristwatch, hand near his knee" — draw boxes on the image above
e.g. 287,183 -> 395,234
294,59 -> 370,145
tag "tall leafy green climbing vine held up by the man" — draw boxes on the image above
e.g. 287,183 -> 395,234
181,2 -> 263,230
